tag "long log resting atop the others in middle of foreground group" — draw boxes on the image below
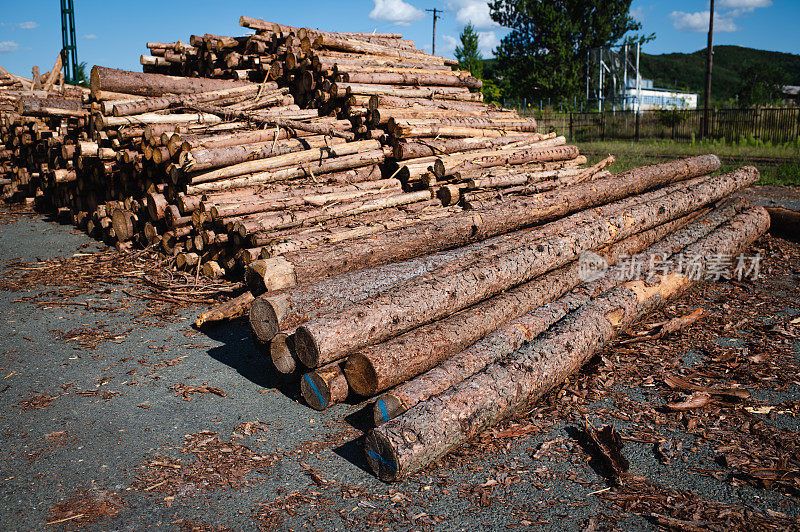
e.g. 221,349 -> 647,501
295,167 -> 759,368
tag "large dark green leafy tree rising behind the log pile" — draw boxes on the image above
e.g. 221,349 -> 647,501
489,0 -> 654,101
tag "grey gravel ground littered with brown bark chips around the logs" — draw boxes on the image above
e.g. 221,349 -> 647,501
0,196 -> 800,530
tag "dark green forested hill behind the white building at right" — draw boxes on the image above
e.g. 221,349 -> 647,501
640,45 -> 800,102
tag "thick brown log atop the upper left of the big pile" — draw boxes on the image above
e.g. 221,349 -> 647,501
89,65 -> 250,99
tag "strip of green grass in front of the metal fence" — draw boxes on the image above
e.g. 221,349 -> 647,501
578,139 -> 800,186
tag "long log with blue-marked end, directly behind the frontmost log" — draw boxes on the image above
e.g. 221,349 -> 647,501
374,202 -> 742,426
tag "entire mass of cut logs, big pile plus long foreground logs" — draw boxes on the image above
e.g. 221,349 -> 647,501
0,25 -> 767,480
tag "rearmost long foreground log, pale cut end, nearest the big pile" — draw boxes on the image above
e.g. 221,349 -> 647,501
242,155 -> 720,296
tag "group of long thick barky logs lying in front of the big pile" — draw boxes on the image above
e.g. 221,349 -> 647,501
248,156 -> 768,480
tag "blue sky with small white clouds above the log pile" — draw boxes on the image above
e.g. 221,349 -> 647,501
0,0 -> 800,77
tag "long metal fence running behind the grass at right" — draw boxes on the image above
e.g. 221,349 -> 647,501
526,107 -> 800,144
